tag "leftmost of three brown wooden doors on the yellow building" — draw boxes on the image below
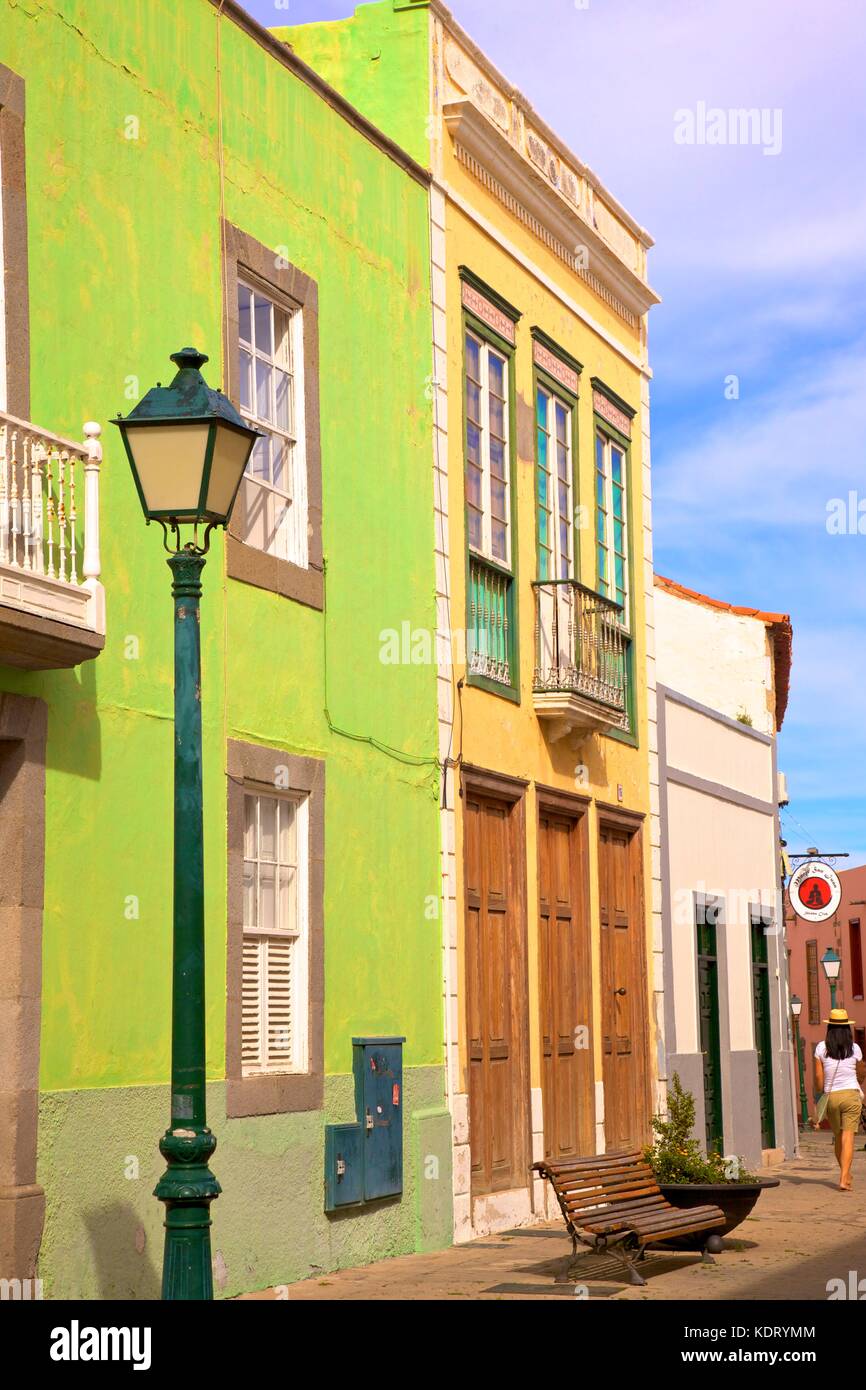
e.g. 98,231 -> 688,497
464,785 -> 530,1195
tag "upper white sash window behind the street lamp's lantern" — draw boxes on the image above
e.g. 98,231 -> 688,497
238,279 -> 309,569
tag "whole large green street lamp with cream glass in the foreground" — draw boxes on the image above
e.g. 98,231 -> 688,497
113,348 -> 260,1300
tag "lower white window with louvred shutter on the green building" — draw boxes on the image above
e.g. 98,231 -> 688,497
240,791 -> 310,1076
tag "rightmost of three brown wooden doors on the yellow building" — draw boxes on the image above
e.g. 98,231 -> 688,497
599,821 -> 651,1151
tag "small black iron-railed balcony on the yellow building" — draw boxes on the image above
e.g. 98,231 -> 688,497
532,580 -> 628,741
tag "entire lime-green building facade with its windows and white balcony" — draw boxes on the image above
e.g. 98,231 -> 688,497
0,0 -> 452,1298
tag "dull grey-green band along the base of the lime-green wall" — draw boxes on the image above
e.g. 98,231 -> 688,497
39,1068 -> 452,1300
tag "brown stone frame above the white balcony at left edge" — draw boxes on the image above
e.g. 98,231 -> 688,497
0,63 -> 31,420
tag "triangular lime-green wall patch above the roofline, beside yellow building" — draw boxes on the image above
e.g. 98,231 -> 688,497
274,0 -> 430,167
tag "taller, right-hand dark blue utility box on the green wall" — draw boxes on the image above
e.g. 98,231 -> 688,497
352,1038 -> 406,1201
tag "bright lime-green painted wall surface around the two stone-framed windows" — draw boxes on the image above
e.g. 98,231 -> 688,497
0,0 -> 442,1289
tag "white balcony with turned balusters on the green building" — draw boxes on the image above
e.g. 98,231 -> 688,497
0,411 -> 106,670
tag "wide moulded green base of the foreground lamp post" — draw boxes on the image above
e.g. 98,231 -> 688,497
153,1129 -> 221,1302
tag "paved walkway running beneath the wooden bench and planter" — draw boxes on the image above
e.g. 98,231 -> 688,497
245,1133 -> 866,1302
